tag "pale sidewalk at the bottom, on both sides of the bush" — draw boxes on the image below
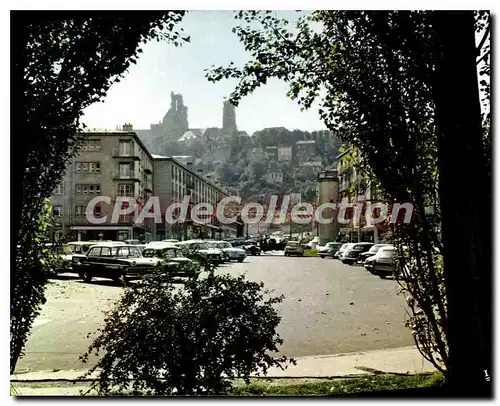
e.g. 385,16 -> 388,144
10,347 -> 435,396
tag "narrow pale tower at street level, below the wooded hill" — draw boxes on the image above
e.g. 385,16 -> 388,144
317,170 -> 339,245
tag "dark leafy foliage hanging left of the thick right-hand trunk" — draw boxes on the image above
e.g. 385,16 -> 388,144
207,11 -> 454,378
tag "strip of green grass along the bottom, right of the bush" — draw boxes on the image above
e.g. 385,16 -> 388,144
230,373 -> 444,396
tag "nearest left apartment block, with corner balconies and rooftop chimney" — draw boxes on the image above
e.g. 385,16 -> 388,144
51,125 -> 153,240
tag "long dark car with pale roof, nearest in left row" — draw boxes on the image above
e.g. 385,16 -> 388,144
73,243 -> 163,282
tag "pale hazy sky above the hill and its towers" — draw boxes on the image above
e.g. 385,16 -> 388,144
82,11 -> 326,134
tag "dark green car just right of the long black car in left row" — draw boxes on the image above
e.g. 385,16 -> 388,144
142,242 -> 200,278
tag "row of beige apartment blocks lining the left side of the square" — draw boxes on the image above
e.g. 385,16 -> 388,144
51,125 -> 236,242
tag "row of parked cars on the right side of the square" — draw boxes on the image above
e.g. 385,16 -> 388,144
319,242 -> 396,278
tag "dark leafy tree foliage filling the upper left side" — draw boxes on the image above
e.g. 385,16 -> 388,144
10,11 -> 189,373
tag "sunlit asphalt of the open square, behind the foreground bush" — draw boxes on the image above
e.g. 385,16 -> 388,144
16,256 -> 413,373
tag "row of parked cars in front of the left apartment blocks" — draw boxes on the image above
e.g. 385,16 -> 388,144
47,240 -> 247,282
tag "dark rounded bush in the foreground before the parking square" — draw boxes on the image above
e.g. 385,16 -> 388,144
81,272 -> 294,395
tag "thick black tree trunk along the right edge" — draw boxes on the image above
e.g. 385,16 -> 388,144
434,11 -> 492,396
